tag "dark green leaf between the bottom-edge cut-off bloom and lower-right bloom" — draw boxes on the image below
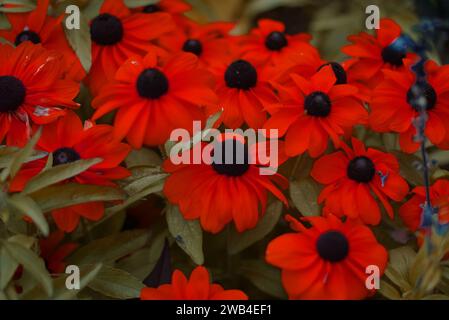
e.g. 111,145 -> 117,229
239,260 -> 287,299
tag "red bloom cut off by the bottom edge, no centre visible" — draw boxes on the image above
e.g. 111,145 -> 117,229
140,266 -> 248,300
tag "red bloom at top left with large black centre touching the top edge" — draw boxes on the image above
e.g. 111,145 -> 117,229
87,0 -> 175,94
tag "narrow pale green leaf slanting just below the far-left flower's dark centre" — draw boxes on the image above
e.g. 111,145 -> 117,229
23,158 -> 102,194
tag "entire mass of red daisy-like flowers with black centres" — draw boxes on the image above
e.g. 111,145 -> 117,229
0,0 -> 449,299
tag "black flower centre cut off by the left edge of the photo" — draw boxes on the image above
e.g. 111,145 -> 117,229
0,76 -> 26,112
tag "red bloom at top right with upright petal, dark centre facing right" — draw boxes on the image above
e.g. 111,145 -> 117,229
342,19 -> 416,86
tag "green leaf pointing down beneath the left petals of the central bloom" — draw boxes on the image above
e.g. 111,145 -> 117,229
166,205 -> 204,265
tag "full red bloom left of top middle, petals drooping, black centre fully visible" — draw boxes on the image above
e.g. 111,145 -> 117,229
92,52 -> 217,149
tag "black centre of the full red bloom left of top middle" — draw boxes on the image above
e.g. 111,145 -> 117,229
136,68 -> 169,99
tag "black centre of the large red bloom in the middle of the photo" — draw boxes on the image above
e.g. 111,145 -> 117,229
212,139 -> 249,177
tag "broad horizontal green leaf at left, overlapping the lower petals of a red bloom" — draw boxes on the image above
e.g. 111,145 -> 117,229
30,183 -> 125,212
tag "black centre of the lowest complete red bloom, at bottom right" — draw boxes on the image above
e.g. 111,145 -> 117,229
316,231 -> 349,262
